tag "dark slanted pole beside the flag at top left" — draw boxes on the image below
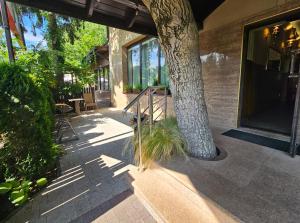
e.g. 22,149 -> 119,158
0,0 -> 15,63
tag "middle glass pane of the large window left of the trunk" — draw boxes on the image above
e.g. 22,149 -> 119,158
142,38 -> 158,88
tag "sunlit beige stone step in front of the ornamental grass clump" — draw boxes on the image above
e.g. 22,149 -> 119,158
129,165 -> 240,223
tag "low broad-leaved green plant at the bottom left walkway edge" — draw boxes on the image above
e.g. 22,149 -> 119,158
0,178 -> 47,206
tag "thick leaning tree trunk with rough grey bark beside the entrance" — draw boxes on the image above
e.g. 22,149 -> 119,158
143,0 -> 216,159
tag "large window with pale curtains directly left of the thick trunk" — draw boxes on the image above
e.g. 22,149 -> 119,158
127,38 -> 169,89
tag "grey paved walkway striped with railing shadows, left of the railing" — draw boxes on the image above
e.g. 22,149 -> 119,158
8,109 -> 155,223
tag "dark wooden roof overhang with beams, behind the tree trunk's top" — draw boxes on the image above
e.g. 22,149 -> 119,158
8,0 -> 225,36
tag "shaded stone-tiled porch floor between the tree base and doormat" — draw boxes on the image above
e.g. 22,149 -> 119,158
162,128 -> 300,223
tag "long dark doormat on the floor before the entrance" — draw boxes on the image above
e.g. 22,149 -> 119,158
222,129 -> 300,155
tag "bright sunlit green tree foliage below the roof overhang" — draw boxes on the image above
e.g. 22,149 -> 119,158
17,5 -> 106,89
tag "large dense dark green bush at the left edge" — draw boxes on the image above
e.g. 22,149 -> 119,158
0,63 -> 58,179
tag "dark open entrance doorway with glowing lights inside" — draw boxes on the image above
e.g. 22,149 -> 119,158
241,20 -> 300,135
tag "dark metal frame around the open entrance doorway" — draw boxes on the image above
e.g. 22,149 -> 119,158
237,8 -> 300,157
